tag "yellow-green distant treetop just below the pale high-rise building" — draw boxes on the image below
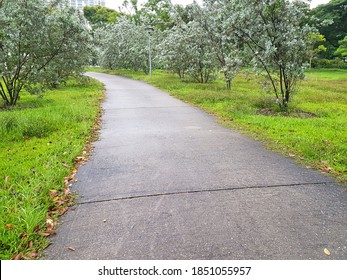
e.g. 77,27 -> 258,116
83,6 -> 121,25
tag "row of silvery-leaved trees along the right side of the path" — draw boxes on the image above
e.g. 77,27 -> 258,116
98,0 -> 317,107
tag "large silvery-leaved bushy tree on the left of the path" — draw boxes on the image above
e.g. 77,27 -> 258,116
0,0 -> 90,106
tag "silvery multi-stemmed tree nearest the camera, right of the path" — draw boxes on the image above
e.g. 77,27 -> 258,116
226,0 -> 315,108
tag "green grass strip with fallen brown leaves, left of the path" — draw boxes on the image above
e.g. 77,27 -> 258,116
0,77 -> 103,259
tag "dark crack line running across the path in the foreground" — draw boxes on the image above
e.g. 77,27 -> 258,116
77,182 -> 333,205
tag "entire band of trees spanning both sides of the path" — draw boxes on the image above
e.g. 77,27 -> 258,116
0,0 -> 347,107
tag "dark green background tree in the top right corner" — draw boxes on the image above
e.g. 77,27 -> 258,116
311,0 -> 347,59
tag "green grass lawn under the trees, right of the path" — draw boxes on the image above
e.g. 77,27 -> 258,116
90,68 -> 347,182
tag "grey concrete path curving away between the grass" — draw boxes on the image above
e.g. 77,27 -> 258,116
45,73 -> 347,259
